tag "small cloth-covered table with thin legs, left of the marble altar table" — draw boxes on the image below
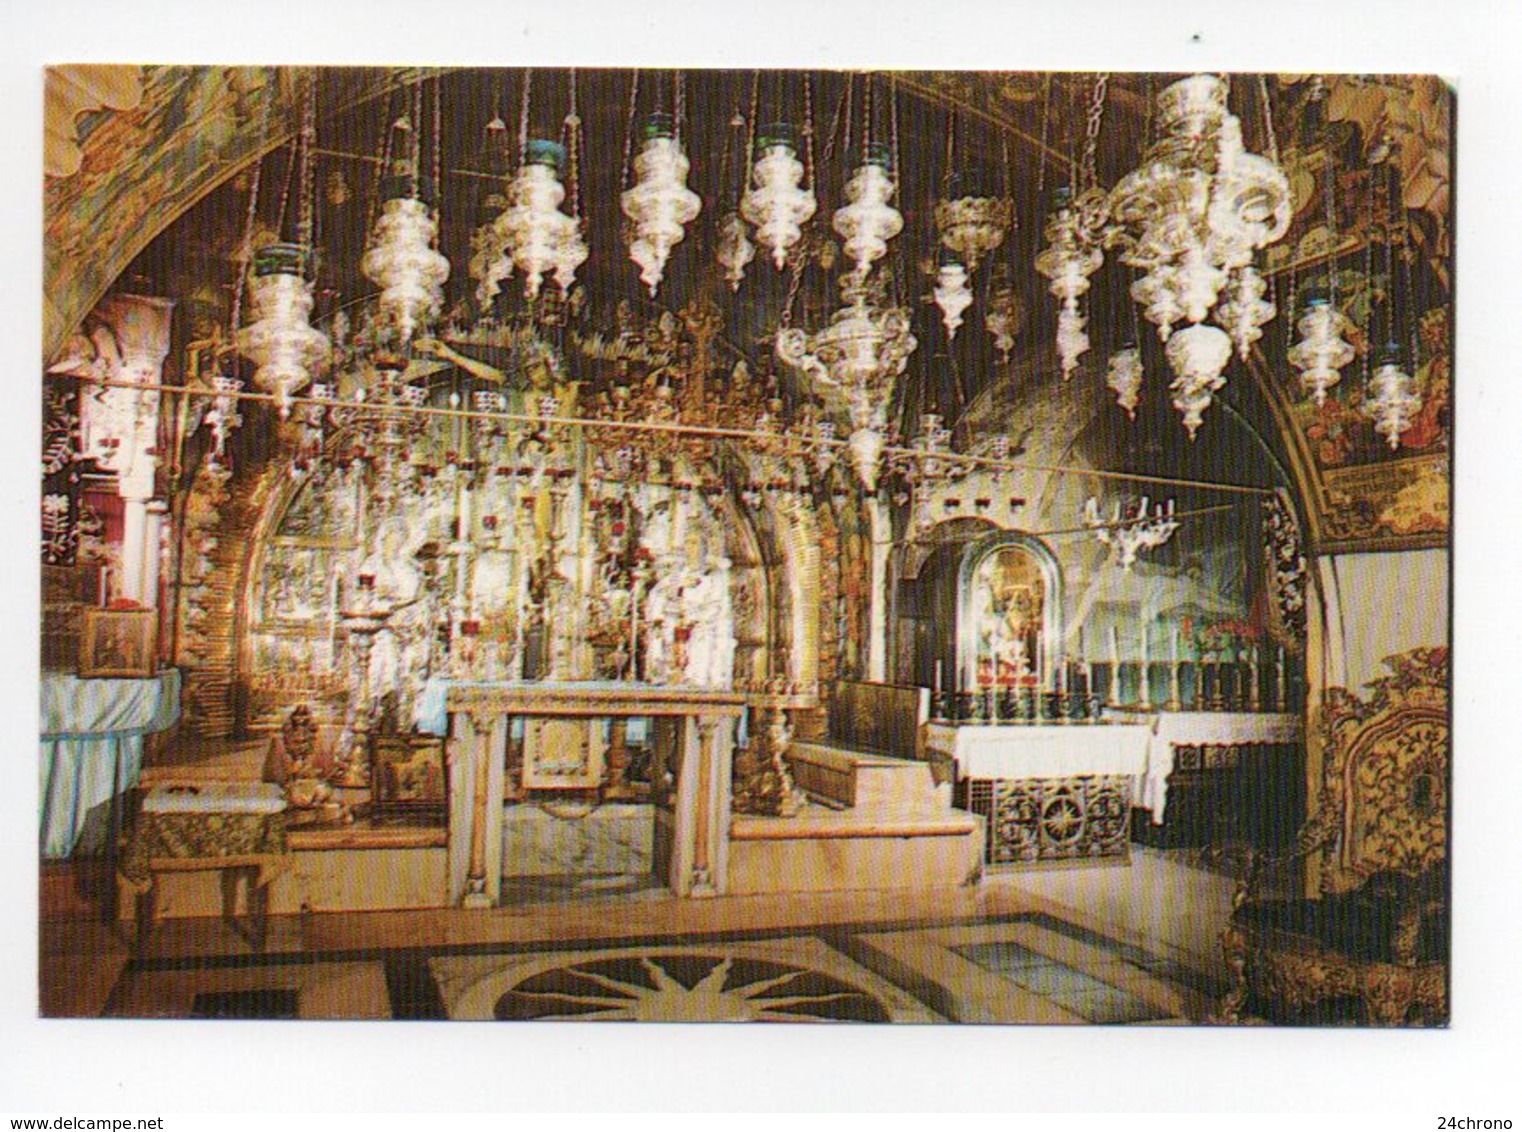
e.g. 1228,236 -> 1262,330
119,782 -> 289,952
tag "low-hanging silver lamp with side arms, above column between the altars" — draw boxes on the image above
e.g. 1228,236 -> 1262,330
776,275 -> 919,491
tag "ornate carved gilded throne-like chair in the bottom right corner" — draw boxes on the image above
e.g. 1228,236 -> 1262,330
1222,648 -> 1449,1025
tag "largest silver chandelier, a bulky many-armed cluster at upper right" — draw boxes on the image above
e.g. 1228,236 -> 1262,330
1106,75 -> 1291,437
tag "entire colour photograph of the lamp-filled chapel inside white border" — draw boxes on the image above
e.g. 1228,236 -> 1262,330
38,64 -> 1455,1027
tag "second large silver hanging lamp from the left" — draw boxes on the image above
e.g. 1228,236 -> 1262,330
359,196 -> 449,345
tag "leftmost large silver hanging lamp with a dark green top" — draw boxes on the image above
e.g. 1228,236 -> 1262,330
236,243 -> 333,418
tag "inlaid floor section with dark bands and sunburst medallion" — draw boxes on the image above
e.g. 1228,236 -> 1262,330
86,911 -> 1221,1024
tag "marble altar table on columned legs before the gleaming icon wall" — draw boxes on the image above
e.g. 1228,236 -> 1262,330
417,680 -> 746,908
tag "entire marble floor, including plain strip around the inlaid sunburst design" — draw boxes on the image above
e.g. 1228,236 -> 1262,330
40,849 -> 1230,1025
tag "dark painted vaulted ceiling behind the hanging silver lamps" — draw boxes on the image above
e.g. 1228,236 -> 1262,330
44,67 -> 1452,548
